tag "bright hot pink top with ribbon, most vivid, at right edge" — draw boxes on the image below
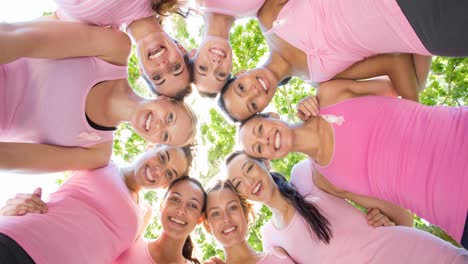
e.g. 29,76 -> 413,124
310,96 -> 468,241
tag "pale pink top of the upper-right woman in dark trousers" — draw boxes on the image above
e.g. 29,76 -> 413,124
265,0 -> 430,82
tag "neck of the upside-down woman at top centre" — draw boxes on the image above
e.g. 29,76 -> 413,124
203,12 -> 235,40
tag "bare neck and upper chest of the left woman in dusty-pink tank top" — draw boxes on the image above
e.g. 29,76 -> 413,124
85,79 -> 144,127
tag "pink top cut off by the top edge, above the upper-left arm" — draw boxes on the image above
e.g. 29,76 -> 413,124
55,0 -> 155,28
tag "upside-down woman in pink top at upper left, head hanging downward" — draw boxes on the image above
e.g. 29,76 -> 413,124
55,0 -> 191,99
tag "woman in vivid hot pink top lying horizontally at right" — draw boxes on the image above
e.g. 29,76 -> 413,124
239,76 -> 468,245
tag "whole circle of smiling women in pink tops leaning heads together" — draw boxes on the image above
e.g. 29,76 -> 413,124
0,0 -> 468,263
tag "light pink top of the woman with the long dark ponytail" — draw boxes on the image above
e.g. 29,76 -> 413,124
262,160 -> 468,264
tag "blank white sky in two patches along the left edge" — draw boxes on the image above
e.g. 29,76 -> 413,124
0,0 -> 59,206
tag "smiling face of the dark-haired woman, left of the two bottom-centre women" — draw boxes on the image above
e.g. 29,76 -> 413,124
161,180 -> 204,239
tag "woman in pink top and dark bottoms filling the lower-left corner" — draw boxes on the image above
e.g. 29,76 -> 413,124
0,145 -> 195,264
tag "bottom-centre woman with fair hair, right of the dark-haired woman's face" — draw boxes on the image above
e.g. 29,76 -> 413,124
203,180 -> 294,264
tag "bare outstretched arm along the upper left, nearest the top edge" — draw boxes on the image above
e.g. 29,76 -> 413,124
0,20 -> 131,65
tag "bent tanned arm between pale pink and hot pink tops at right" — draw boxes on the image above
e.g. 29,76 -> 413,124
335,53 -> 419,102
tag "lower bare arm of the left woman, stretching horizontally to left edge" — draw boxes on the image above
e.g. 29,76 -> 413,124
0,141 -> 112,173
